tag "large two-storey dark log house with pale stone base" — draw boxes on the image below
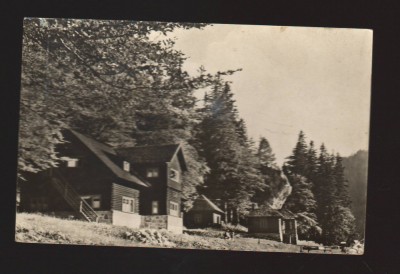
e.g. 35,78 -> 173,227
20,130 -> 187,232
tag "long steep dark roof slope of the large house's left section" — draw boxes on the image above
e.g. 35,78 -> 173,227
69,129 -> 150,187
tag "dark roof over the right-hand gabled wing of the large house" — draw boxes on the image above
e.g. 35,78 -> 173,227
116,144 -> 187,170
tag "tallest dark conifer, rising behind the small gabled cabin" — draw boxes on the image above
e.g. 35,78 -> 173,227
198,82 -> 262,221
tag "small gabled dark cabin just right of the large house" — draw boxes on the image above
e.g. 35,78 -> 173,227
184,195 -> 224,228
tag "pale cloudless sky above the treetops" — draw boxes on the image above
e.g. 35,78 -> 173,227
166,24 -> 372,165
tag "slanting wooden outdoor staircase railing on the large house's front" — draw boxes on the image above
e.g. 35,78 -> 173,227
51,170 -> 99,222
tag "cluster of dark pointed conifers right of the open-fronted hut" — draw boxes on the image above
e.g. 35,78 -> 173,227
283,131 -> 359,244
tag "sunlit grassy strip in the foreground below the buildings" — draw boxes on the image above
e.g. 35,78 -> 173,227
15,213 -> 300,252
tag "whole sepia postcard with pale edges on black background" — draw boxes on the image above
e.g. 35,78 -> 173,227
15,18 -> 372,254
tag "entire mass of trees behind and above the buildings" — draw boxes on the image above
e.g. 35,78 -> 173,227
18,19 -> 362,244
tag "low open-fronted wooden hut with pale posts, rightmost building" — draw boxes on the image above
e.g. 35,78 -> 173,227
247,206 -> 298,244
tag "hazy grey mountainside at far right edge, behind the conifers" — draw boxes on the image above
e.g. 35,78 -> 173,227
343,150 -> 368,238
